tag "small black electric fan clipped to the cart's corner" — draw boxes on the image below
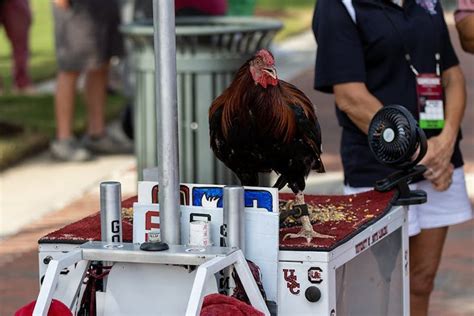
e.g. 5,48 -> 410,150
368,105 -> 427,205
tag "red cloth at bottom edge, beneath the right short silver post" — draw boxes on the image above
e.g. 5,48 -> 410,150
201,293 -> 264,316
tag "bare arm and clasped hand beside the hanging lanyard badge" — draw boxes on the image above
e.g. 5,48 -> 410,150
420,66 -> 466,191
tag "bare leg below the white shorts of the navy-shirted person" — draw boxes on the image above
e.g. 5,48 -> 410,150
410,227 -> 448,316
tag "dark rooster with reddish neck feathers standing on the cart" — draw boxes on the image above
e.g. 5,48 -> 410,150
209,49 -> 333,243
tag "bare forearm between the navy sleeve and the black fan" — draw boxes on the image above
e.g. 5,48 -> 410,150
334,82 -> 382,134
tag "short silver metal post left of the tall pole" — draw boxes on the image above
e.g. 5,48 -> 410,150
100,181 -> 122,242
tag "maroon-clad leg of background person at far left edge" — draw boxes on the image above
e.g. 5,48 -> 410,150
0,0 -> 34,94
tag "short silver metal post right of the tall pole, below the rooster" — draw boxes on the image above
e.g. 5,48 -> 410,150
224,185 -> 245,254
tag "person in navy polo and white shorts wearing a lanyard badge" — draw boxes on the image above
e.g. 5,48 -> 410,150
313,0 -> 472,315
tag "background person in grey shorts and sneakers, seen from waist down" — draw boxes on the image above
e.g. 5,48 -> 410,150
50,0 -> 130,161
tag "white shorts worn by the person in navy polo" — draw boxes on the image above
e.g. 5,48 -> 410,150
344,167 -> 473,236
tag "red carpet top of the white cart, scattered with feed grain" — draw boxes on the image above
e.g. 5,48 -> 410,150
39,191 -> 395,250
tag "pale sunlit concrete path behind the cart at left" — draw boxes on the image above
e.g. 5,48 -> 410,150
0,122 -> 136,241
